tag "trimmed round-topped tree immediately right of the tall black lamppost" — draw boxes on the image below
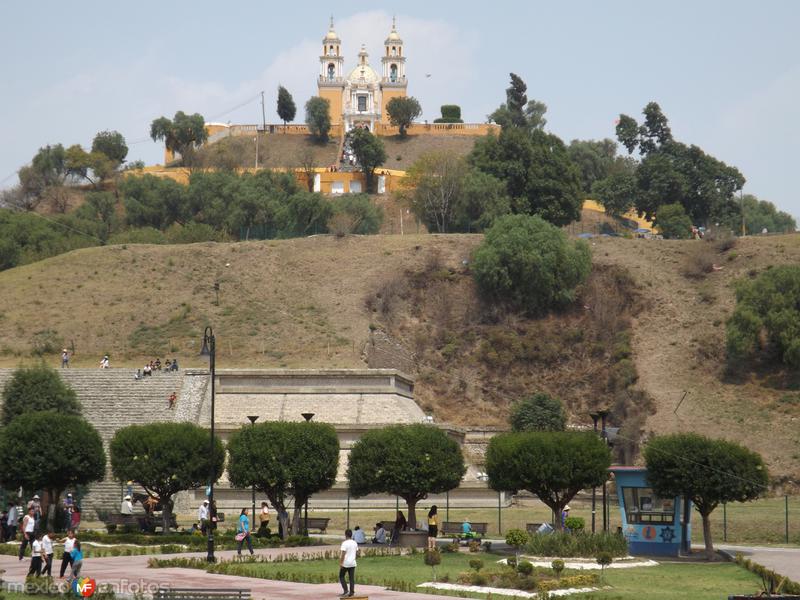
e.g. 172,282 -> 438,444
228,421 -> 339,539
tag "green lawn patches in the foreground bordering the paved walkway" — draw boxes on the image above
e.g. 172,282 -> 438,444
186,553 -> 760,600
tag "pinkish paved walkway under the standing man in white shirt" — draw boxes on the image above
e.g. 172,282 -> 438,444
0,546 -> 438,600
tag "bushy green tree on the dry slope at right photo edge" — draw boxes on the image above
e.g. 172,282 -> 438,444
727,265 -> 800,369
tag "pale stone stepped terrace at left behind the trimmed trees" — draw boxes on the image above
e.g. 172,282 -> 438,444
0,369 -> 193,516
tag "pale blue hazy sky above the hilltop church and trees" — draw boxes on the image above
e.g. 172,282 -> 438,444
0,0 -> 800,219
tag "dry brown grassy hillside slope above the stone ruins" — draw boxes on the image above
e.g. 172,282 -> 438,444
0,235 -> 800,478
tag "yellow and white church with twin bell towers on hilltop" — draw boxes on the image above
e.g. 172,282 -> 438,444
317,18 -> 408,132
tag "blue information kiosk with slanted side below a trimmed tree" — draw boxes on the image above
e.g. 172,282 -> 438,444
609,466 -> 692,556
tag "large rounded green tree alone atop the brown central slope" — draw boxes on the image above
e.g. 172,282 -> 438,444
472,215 -> 591,315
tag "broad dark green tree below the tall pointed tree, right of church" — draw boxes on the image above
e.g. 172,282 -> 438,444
469,128 -> 583,225
